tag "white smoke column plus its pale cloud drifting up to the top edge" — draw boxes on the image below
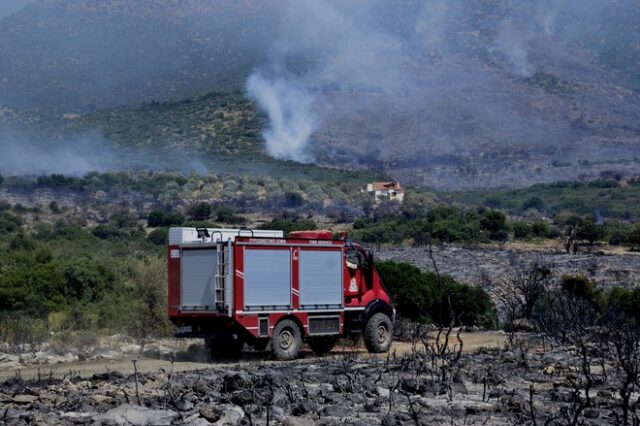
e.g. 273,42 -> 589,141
246,0 -> 415,162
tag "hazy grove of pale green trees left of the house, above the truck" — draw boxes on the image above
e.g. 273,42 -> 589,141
0,171 -> 370,215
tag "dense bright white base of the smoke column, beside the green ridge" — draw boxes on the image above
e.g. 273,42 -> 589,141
246,71 -> 317,162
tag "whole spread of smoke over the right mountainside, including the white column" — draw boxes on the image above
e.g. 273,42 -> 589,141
246,0 -> 640,179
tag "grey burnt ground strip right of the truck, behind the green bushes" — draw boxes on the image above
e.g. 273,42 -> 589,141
375,245 -> 640,288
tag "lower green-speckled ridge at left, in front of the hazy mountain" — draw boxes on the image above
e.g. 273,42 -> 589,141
0,92 -> 385,184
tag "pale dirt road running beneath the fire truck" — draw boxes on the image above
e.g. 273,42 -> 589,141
0,332 -> 506,382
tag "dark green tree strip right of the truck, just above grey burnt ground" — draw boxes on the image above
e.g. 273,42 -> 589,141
353,201 -> 640,253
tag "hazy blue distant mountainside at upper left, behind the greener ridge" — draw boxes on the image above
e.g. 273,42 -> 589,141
0,0 -> 266,111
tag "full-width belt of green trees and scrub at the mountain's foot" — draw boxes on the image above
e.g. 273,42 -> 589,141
5,171 -> 640,252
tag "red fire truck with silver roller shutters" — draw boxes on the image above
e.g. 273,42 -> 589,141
167,228 -> 395,360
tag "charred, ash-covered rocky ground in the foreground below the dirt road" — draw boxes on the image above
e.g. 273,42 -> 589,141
0,335 -> 637,425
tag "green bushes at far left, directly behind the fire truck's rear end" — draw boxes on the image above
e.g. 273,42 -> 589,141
0,212 -> 171,344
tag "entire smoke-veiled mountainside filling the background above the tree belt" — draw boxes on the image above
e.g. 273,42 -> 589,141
0,0 -> 640,190
